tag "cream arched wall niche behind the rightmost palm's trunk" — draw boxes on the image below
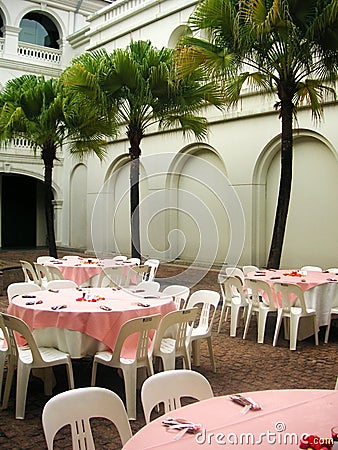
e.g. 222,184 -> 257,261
252,129 -> 338,268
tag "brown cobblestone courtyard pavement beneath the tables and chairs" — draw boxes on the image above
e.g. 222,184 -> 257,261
0,249 -> 338,450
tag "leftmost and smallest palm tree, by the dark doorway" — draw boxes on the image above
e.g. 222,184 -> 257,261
0,75 -> 115,257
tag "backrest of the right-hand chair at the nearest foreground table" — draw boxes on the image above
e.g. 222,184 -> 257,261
141,369 -> 214,423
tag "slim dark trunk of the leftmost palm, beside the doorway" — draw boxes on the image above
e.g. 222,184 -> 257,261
42,145 -> 57,258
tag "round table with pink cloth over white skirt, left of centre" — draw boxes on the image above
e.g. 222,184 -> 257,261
7,288 -> 176,358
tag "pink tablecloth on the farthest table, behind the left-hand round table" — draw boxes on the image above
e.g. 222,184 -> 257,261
45,257 -> 135,286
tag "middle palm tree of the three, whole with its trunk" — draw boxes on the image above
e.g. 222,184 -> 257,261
65,41 -> 222,258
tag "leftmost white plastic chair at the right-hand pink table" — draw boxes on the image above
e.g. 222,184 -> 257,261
218,274 -> 248,337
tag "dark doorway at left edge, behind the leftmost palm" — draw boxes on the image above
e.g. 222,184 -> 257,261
1,174 -> 37,248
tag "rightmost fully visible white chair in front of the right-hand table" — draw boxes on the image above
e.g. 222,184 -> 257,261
273,283 -> 318,350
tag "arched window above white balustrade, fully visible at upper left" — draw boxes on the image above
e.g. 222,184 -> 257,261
19,12 -> 60,49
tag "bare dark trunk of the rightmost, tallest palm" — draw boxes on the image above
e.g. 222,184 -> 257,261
267,100 -> 293,269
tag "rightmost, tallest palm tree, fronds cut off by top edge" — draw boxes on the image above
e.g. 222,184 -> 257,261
178,0 -> 338,268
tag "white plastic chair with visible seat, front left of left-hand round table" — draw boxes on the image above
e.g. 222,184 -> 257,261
1,313 -> 74,419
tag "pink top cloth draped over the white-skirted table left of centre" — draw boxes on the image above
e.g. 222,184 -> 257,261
8,288 -> 176,357
